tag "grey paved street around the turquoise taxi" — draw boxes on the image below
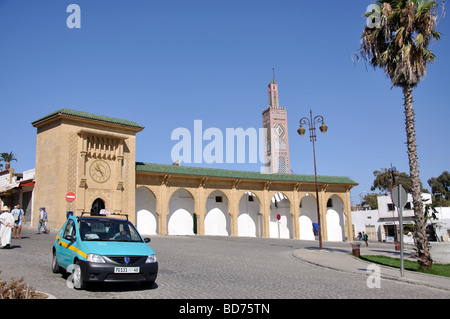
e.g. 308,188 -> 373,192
0,228 -> 450,299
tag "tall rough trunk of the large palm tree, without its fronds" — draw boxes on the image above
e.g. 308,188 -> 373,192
403,85 -> 433,268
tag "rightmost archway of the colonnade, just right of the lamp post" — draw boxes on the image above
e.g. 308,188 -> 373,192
327,195 -> 345,241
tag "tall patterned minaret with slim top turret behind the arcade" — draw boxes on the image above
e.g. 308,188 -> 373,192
262,69 -> 291,174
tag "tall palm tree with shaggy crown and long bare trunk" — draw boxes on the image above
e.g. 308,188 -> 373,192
359,0 -> 441,268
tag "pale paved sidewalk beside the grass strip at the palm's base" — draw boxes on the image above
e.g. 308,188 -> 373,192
292,242 -> 450,297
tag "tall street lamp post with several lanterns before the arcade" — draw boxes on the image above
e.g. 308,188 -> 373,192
297,110 -> 328,249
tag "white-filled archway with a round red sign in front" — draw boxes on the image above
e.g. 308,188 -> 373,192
269,193 -> 294,238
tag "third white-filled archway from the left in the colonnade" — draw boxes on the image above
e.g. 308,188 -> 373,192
205,190 -> 231,236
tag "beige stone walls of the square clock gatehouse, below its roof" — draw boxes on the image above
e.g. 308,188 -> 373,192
33,116 -> 141,228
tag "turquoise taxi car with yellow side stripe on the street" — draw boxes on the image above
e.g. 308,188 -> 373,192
52,212 -> 158,289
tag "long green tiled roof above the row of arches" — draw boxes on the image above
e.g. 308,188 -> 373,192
136,162 -> 358,186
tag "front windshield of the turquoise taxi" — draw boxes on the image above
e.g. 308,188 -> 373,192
80,218 -> 142,242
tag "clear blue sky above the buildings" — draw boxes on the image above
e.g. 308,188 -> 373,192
0,0 -> 450,203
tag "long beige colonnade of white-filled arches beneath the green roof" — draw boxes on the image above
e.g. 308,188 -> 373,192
135,168 -> 353,241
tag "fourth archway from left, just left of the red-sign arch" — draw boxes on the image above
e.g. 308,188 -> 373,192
238,192 -> 262,237
